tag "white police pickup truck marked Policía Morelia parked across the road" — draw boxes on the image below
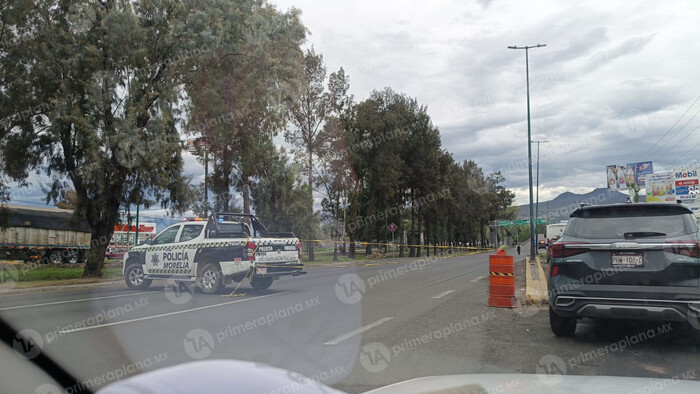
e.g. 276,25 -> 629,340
123,213 -> 306,294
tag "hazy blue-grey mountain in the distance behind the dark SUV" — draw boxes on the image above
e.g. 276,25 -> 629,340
518,188 -> 645,223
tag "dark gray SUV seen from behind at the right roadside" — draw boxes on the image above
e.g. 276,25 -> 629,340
548,203 -> 700,336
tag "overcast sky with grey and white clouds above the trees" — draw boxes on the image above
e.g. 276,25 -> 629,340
9,0 -> 700,215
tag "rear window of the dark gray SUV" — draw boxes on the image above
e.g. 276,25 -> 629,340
565,207 -> 698,239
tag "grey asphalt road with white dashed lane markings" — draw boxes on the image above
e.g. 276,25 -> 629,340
0,245 -> 700,392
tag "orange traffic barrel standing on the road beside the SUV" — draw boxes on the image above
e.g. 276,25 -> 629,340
488,249 -> 515,308
